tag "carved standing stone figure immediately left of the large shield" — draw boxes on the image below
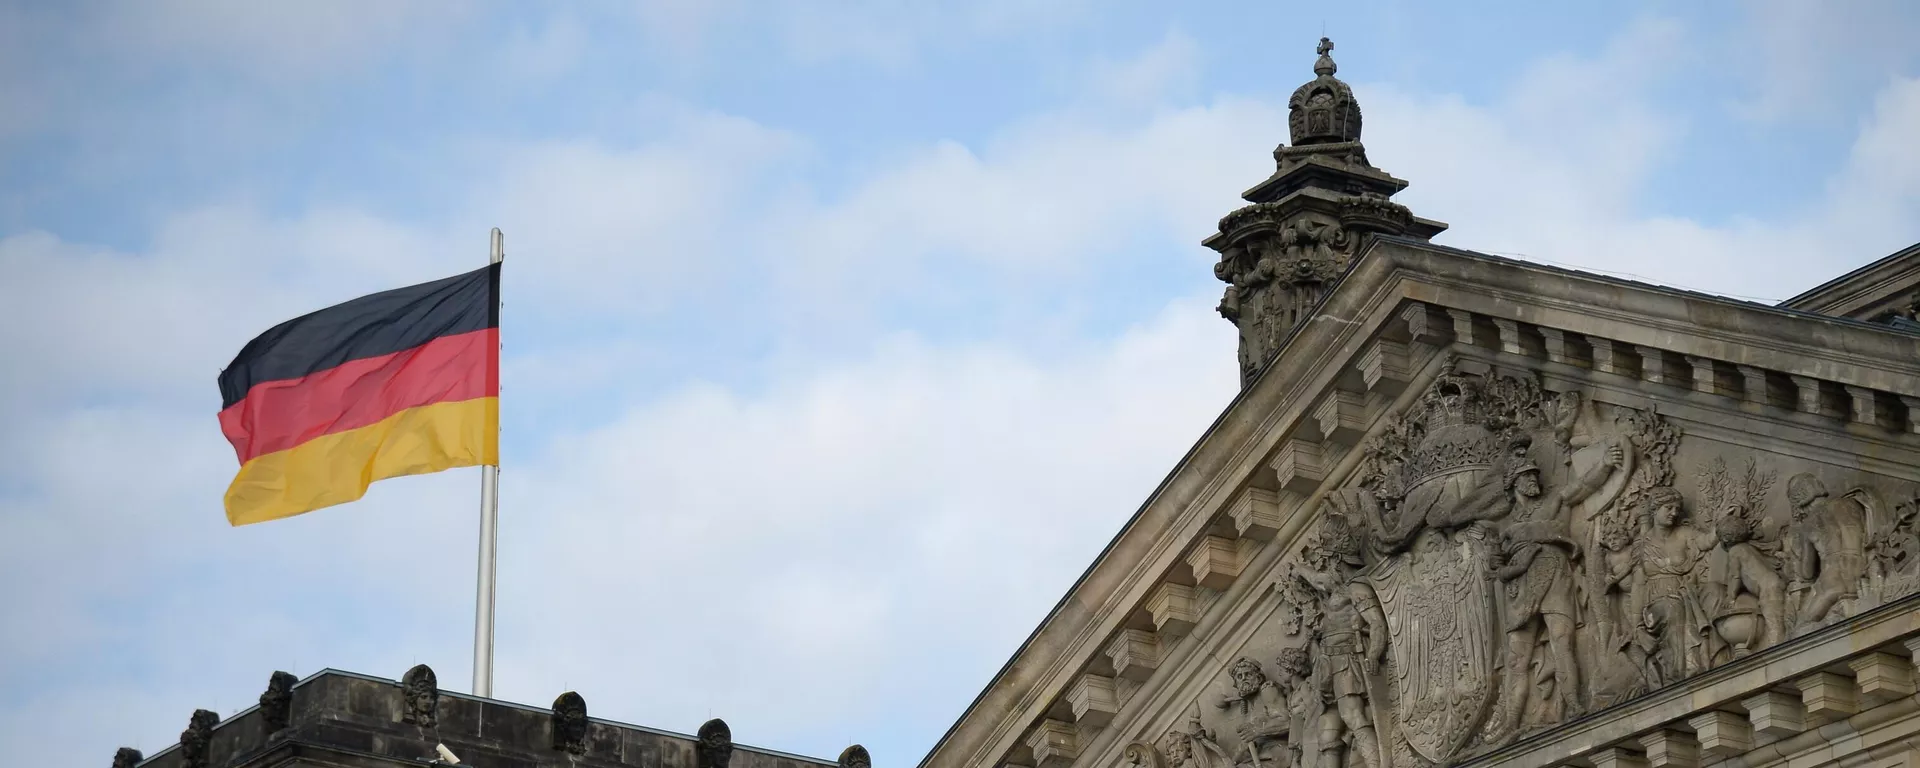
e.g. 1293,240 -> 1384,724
1298,509 -> 1388,766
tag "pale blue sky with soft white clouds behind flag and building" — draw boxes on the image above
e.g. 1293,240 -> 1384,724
0,0 -> 1920,766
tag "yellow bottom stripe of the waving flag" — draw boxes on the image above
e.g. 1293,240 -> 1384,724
227,397 -> 499,526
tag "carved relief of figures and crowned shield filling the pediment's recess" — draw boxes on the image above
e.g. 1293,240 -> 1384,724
1144,361 -> 1920,768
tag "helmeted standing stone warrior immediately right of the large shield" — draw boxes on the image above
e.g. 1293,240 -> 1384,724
1488,435 -> 1624,735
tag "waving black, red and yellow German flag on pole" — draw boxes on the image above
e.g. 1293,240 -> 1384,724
221,263 -> 499,526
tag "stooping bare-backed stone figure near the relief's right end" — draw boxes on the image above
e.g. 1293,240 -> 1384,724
1788,472 -> 1866,628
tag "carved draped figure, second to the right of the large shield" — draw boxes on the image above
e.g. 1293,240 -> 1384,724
1628,486 -> 1715,687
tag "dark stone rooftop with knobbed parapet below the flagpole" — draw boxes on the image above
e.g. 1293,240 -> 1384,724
113,664 -> 872,768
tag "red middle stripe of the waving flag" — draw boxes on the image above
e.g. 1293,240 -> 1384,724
221,328 -> 499,465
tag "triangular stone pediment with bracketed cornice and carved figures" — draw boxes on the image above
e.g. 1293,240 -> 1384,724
924,238 -> 1920,768
